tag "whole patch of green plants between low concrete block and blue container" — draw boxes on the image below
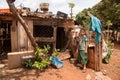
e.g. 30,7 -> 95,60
24,45 -> 60,70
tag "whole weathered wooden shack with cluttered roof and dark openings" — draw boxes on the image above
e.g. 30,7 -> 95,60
0,8 -> 74,53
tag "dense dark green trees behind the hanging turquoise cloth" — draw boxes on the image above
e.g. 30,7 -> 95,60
76,0 -> 120,41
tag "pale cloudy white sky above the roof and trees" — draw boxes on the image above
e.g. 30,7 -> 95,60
0,0 -> 101,15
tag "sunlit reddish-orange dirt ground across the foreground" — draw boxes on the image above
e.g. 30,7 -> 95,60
0,45 -> 120,80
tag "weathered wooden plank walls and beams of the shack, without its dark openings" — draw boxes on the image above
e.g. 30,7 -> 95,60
0,9 -> 74,52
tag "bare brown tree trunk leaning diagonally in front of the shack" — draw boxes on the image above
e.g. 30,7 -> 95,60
7,0 -> 38,49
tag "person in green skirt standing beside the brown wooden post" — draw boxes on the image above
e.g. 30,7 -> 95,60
76,28 -> 88,72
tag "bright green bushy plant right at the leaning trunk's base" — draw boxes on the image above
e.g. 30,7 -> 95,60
32,45 -> 50,70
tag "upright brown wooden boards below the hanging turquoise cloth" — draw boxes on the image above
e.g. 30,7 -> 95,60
88,31 -> 102,71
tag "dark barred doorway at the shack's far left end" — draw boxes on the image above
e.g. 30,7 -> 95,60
0,20 -> 12,57
